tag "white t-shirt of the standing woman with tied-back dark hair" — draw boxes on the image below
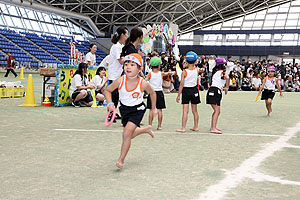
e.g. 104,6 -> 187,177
107,42 -> 124,80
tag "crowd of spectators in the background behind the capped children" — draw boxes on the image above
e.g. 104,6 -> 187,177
145,52 -> 300,92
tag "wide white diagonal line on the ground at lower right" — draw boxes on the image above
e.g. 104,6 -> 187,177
198,122 -> 300,200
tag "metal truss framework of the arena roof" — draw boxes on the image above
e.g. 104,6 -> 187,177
32,0 -> 293,34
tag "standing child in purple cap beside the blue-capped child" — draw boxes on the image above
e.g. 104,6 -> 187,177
206,57 -> 230,134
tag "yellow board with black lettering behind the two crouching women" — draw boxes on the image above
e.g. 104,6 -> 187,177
54,65 -> 97,107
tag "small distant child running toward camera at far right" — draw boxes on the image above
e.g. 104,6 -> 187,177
258,66 -> 283,116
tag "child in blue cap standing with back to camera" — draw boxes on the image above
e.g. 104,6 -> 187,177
176,51 -> 201,132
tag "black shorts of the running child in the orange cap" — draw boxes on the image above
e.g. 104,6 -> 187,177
119,102 -> 146,127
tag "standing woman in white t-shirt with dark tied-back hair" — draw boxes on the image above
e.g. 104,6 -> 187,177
107,26 -> 128,119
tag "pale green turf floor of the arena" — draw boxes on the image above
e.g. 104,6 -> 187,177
0,73 -> 300,200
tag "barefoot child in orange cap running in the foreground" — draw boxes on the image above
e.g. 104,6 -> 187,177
105,53 -> 157,168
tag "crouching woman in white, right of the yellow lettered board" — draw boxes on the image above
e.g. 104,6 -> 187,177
90,67 -> 108,106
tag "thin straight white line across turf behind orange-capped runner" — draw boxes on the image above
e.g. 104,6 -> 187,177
53,129 -> 286,137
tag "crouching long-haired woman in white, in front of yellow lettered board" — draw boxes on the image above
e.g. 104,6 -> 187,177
69,63 -> 94,107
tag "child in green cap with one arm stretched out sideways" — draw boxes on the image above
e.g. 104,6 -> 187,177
145,56 -> 173,130
